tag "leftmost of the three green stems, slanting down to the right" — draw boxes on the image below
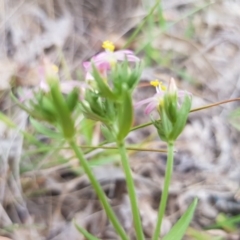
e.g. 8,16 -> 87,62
69,140 -> 129,240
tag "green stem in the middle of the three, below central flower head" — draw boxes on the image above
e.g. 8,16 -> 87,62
118,142 -> 144,240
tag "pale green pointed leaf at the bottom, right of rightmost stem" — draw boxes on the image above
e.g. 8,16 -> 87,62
162,198 -> 198,240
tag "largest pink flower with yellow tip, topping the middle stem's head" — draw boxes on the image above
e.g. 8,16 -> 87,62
83,41 -> 140,80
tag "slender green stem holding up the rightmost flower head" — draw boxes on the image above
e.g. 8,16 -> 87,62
152,142 -> 174,240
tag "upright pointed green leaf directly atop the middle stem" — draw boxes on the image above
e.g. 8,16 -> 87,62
117,86 -> 133,141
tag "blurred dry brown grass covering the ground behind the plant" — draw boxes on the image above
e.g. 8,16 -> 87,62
0,0 -> 240,240
